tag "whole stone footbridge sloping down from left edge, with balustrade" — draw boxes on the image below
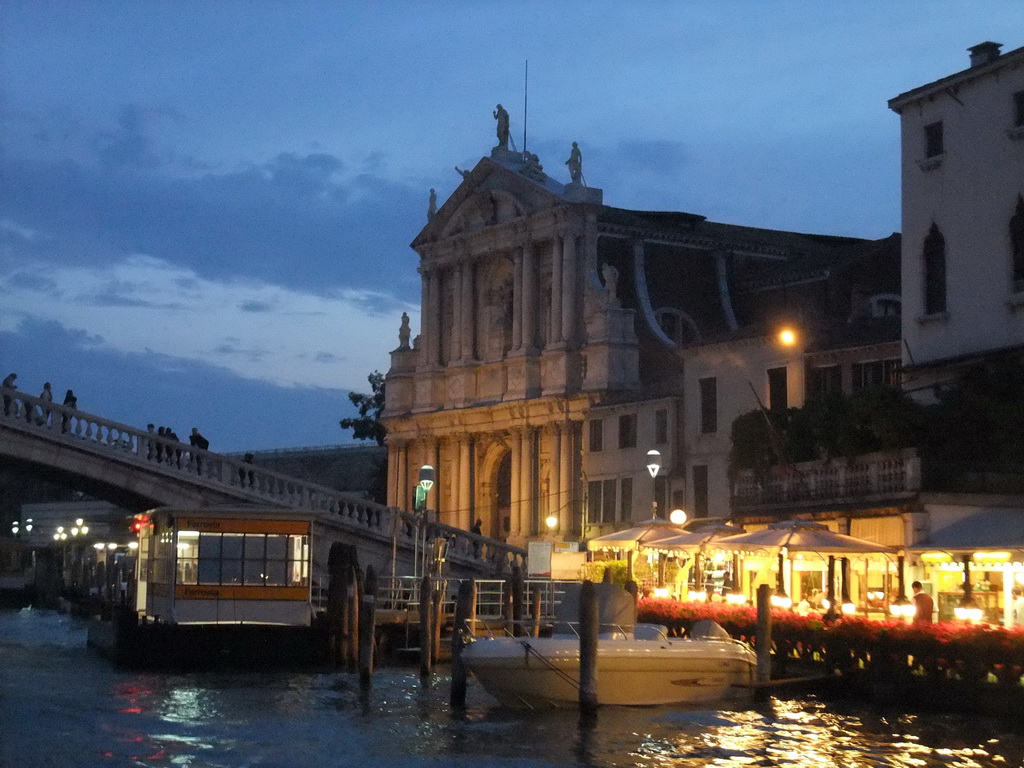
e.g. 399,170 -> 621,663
0,388 -> 526,578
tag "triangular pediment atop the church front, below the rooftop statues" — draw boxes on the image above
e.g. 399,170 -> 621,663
412,158 -> 566,248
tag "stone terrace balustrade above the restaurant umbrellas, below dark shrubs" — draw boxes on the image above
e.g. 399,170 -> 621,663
732,449 -> 922,509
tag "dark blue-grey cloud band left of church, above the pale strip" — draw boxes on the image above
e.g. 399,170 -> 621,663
0,105 -> 427,300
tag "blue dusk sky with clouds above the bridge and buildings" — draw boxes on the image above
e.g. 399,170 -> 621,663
0,0 -> 1024,452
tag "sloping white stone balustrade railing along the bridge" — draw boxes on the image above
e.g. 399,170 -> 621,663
0,387 -> 526,574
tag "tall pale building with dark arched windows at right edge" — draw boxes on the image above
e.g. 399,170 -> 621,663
889,42 -> 1024,385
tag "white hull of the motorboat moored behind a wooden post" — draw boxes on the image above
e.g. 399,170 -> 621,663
463,638 -> 757,707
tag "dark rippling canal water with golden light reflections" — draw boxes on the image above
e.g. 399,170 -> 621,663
0,609 -> 1024,768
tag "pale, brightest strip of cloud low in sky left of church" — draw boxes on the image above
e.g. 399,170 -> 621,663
0,256 -> 418,388
